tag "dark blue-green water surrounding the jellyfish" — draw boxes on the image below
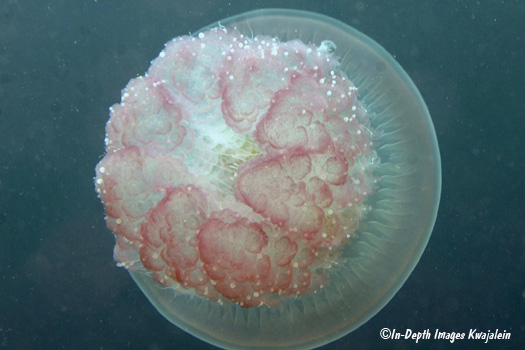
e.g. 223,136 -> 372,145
0,0 -> 525,349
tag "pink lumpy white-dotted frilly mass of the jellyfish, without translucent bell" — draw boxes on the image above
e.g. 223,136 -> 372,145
96,28 -> 378,307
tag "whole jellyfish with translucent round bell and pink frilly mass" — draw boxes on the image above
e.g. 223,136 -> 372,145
95,10 -> 441,349
